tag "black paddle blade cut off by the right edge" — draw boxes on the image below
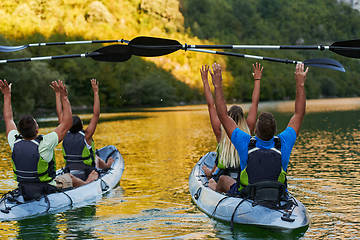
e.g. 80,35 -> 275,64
329,39 -> 360,58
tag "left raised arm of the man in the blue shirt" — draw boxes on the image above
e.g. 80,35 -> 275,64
210,63 -> 237,139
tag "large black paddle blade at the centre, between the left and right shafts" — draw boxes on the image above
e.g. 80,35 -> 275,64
129,36 -> 182,57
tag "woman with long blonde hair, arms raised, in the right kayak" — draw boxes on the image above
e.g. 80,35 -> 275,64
200,63 -> 264,190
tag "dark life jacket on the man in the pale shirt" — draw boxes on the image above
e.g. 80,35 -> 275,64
11,135 -> 56,183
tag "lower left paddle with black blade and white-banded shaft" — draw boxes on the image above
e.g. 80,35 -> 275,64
0,44 -> 132,63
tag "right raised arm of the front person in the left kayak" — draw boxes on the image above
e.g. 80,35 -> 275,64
85,79 -> 100,145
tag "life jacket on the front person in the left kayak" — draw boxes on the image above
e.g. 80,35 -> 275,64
62,130 -> 95,181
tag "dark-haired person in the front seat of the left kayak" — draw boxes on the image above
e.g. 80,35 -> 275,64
52,79 -> 114,181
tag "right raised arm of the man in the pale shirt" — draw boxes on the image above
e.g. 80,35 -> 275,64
54,80 -> 72,143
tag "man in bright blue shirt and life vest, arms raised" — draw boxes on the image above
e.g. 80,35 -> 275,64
210,63 -> 309,194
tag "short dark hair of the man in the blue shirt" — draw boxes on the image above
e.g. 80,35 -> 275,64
256,112 -> 276,141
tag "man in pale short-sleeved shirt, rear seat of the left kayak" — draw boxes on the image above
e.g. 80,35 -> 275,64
0,80 -> 97,200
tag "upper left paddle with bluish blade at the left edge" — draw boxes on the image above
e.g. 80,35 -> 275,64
0,39 -> 128,52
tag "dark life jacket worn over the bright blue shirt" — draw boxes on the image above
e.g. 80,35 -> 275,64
237,137 -> 286,191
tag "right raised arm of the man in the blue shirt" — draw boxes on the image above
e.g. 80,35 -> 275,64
288,63 -> 309,136
